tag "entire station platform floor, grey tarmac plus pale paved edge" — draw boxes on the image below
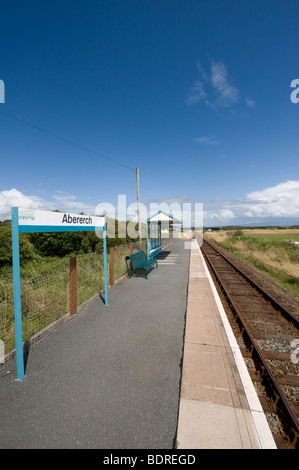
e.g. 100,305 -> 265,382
0,240 -> 276,450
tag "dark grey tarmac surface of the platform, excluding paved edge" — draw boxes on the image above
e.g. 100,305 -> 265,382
0,241 -> 190,449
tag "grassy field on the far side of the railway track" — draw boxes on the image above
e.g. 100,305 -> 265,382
204,228 -> 299,296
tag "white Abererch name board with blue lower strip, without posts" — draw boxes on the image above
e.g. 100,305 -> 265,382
18,209 -> 106,232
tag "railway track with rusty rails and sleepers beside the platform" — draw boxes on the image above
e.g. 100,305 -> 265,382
201,240 -> 299,449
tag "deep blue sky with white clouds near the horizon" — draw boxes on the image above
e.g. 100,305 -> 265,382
0,0 -> 299,225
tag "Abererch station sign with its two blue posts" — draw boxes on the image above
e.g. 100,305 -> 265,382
11,207 -> 108,380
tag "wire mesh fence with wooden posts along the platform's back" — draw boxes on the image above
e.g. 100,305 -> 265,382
0,240 -> 167,366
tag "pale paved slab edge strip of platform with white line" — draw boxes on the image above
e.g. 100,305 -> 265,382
177,240 -> 276,449
